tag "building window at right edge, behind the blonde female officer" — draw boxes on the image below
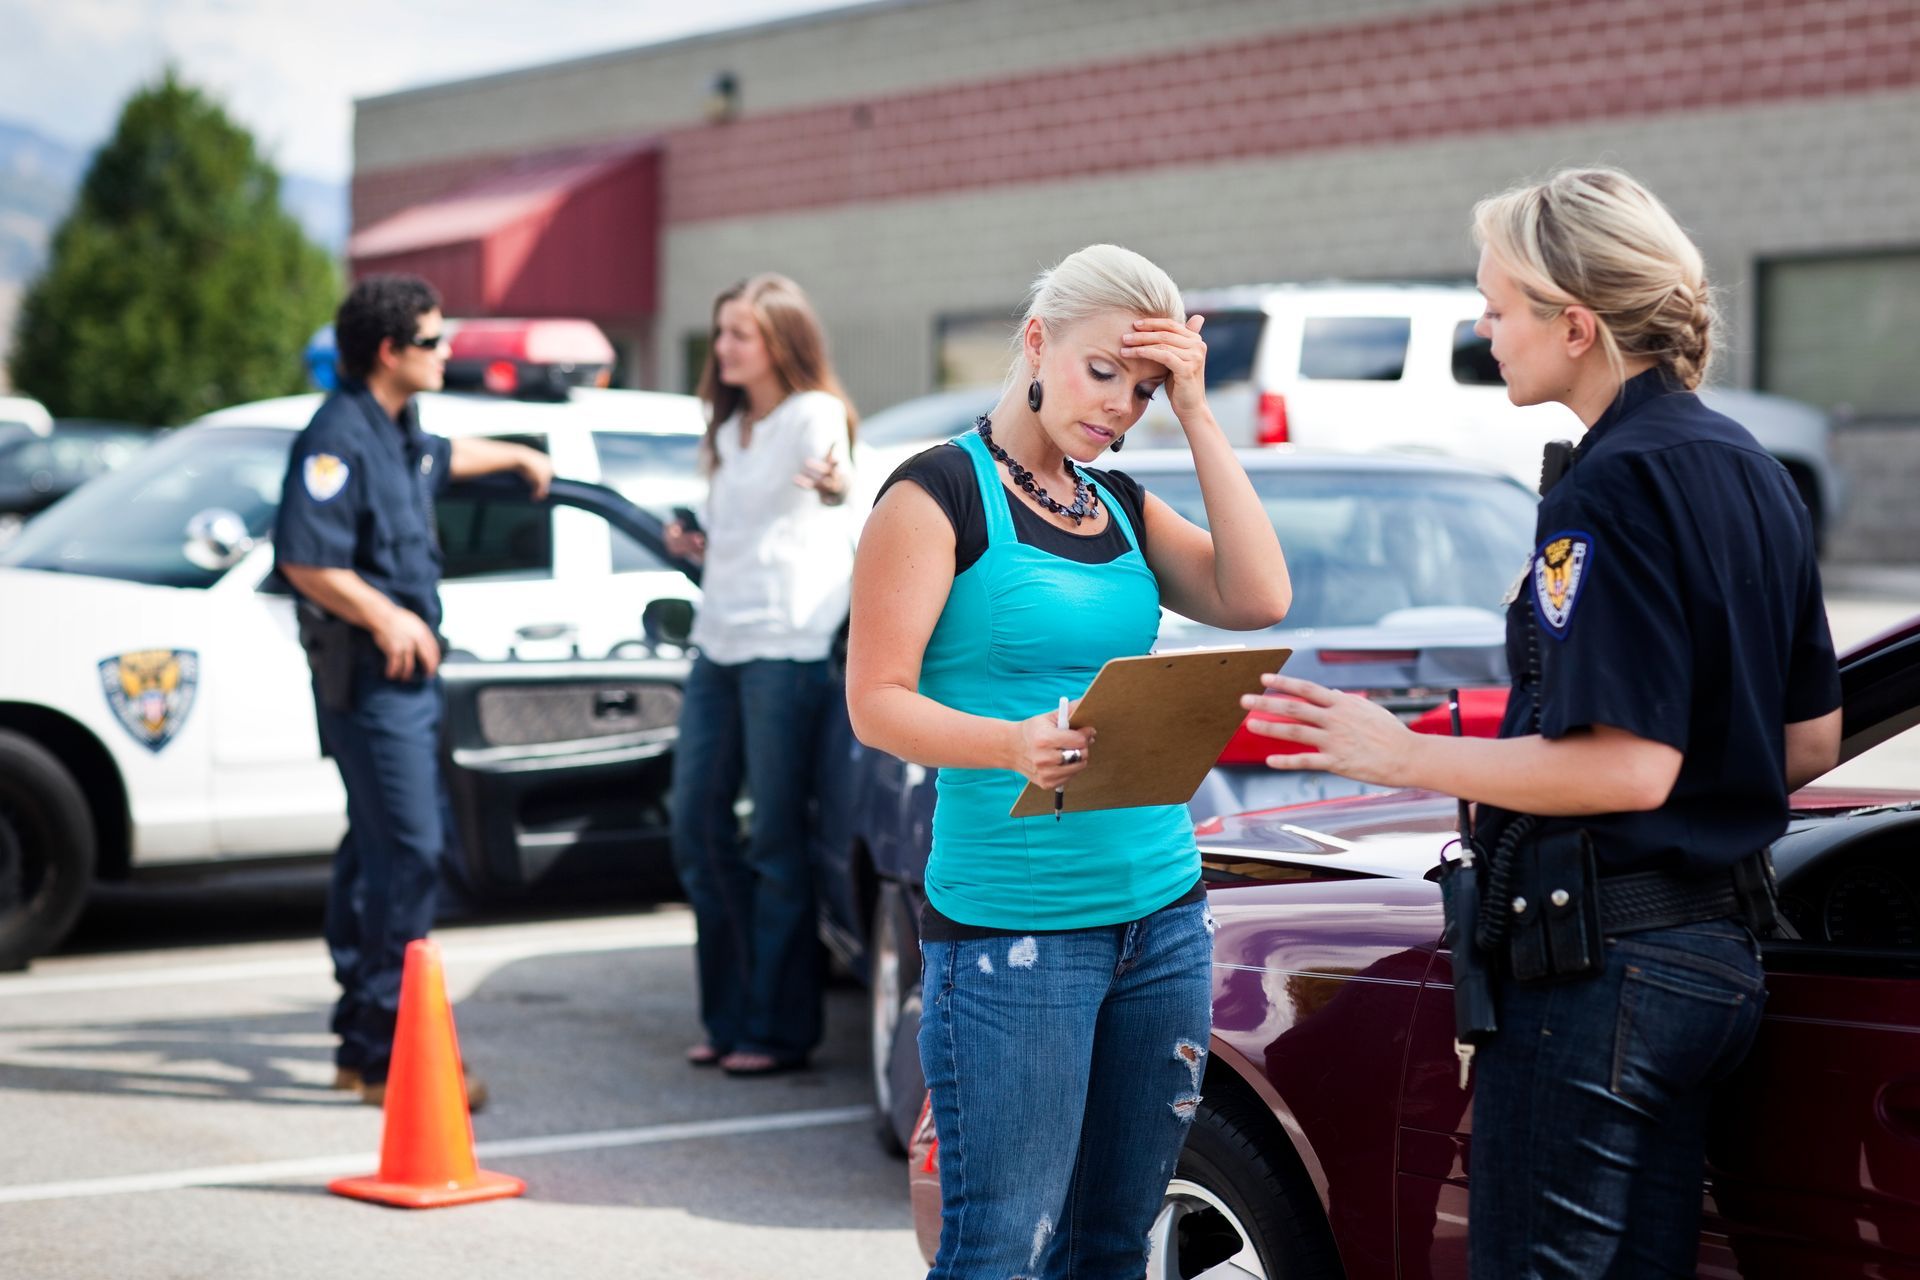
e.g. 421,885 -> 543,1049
1757,249 -> 1920,424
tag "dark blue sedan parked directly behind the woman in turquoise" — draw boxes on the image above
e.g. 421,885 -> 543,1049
820,451 -> 1536,1148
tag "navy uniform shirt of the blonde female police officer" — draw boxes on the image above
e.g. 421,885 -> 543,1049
1490,368 -> 1839,873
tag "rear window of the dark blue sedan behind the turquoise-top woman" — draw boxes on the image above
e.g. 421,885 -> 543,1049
1133,466 -> 1534,629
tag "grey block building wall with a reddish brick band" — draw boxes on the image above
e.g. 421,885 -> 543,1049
355,0 -> 1920,560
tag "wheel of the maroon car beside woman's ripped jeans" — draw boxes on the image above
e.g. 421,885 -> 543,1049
1146,1096 -> 1342,1280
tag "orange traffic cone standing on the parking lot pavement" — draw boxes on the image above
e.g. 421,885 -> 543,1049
326,938 -> 526,1209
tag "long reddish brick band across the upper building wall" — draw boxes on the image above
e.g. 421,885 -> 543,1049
666,0 -> 1920,223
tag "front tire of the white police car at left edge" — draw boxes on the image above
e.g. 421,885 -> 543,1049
0,729 -> 96,969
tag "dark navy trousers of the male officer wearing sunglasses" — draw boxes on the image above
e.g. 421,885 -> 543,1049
319,664 -> 445,1082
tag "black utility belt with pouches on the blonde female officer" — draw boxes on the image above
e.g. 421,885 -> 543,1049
1486,829 -> 1778,983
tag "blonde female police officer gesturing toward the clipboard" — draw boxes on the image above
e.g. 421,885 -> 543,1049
1248,169 -> 1839,1280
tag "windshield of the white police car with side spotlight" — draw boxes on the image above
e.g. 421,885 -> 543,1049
0,426 -> 294,587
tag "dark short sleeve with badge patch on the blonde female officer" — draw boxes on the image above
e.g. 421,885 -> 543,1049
1526,476 -> 1693,752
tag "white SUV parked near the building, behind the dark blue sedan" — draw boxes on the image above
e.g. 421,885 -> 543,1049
1135,282 -> 1843,535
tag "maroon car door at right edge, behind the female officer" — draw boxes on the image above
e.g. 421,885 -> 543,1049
1701,622 -> 1920,1280
